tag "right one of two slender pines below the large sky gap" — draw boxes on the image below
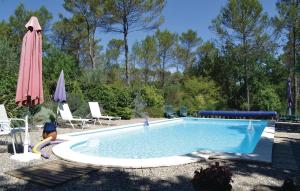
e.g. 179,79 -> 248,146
176,29 -> 202,73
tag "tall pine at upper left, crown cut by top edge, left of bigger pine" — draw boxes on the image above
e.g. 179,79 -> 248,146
64,0 -> 104,68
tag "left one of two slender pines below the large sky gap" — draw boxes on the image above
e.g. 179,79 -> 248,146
155,30 -> 177,87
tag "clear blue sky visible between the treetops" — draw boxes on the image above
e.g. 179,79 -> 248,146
0,0 -> 276,45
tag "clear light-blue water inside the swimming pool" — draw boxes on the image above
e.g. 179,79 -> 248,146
71,118 -> 267,159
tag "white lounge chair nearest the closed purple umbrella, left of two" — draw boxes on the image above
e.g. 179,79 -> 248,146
58,103 -> 90,129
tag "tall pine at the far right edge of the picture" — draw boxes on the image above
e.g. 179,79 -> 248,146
273,0 -> 300,114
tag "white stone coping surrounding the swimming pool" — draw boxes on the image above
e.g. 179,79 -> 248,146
52,118 -> 275,168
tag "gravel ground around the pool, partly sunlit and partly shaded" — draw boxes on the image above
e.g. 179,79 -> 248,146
0,119 -> 300,191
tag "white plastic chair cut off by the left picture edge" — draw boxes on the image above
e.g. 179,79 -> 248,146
0,104 -> 25,154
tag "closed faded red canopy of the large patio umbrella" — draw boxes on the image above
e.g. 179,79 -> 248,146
16,17 -> 44,106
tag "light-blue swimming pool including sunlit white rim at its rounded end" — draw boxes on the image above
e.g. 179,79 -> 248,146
53,118 -> 274,166
